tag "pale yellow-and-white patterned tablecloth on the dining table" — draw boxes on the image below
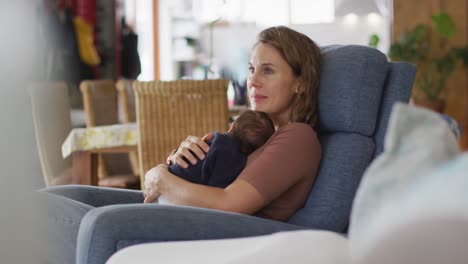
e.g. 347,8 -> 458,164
62,123 -> 138,158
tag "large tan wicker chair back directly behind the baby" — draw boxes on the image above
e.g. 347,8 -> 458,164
134,80 -> 228,187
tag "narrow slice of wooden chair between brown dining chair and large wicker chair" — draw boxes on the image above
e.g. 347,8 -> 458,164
115,79 -> 140,175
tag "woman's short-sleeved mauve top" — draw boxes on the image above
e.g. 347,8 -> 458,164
239,123 -> 322,221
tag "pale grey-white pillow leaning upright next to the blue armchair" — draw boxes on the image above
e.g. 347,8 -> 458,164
349,103 -> 460,254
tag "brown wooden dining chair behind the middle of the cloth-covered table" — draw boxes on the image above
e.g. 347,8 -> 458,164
80,80 -> 139,188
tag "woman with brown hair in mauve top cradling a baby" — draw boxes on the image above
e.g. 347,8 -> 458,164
38,26 -> 321,263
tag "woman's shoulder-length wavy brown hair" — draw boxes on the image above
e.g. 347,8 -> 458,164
257,26 -> 322,127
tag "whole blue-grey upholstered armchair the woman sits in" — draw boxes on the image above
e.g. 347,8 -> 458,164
77,45 -> 415,263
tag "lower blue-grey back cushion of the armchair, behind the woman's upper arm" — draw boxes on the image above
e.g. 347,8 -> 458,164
289,133 -> 374,232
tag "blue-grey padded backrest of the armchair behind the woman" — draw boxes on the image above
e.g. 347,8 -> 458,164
289,45 -> 416,232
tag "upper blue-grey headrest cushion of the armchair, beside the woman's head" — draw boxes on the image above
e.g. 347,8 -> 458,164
318,45 -> 389,136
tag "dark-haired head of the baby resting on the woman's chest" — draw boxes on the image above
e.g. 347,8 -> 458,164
229,110 -> 275,155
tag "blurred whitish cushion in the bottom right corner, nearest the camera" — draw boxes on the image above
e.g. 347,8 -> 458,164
350,153 -> 468,264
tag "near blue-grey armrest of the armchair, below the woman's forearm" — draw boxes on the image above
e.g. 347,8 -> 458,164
77,204 -> 305,264
